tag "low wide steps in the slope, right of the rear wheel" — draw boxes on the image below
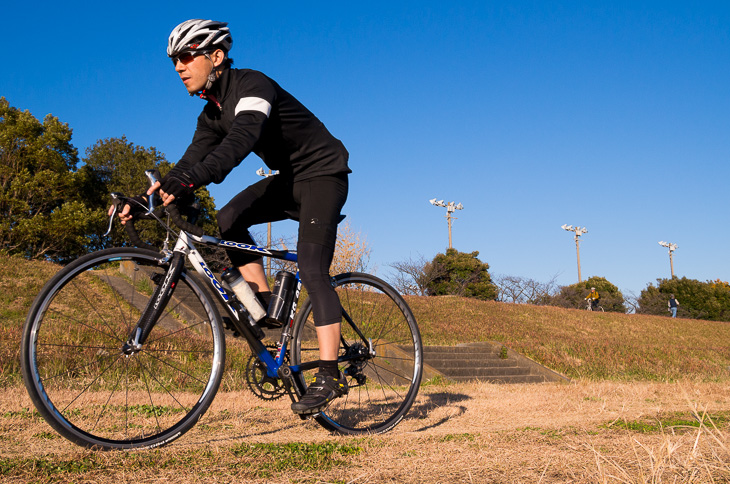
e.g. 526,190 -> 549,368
423,342 -> 569,383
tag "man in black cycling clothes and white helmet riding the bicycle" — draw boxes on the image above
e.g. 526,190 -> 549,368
120,19 -> 351,414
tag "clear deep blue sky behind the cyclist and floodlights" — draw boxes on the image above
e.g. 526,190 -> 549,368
5,1 -> 730,295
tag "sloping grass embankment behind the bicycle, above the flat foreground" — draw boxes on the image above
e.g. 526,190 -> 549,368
0,256 -> 730,387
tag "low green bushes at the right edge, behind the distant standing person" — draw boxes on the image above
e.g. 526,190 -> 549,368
637,277 -> 730,321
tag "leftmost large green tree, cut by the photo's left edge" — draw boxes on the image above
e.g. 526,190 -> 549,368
0,97 -> 98,261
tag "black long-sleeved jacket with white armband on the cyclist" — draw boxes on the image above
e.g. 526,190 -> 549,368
173,69 -> 350,186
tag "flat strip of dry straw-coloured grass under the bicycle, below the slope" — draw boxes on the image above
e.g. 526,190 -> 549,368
0,382 -> 730,483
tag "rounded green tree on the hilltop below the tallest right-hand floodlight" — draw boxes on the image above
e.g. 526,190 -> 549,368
426,249 -> 497,300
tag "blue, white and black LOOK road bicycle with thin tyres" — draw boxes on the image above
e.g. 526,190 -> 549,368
21,171 -> 423,449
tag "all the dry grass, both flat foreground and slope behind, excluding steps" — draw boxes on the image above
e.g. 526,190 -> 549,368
0,258 -> 730,484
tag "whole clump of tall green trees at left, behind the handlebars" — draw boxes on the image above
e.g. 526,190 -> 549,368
0,98 -> 222,263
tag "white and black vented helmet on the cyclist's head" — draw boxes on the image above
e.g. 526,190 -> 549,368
167,19 -> 233,57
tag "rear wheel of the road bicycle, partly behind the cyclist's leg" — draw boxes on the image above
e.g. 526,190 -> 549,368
291,273 -> 423,435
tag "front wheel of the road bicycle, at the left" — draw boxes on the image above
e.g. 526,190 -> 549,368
21,248 -> 225,449
